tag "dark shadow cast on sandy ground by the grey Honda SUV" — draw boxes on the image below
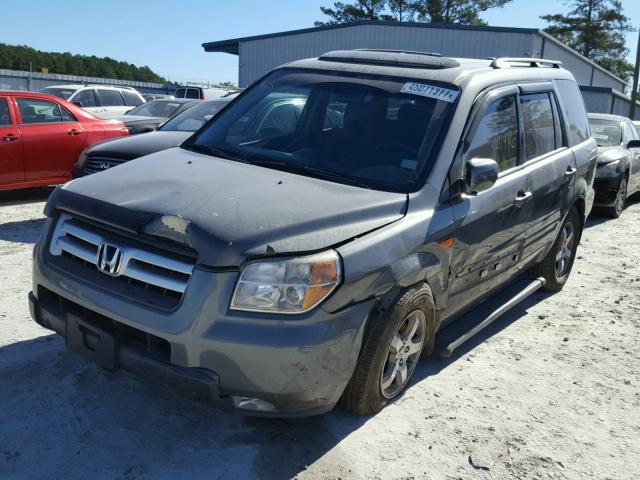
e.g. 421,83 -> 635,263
0,293 -> 548,480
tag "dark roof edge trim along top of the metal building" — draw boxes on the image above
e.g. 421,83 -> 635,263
202,20 -> 625,84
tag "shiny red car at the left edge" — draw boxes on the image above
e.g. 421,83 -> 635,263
0,91 -> 128,190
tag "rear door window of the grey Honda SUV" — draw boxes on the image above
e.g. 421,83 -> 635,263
520,92 -> 556,160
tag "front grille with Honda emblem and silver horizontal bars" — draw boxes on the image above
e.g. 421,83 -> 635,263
49,214 -> 195,309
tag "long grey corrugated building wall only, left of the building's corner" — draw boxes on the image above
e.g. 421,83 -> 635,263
239,25 -> 535,87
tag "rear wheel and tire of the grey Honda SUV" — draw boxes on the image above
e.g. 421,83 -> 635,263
531,207 -> 582,292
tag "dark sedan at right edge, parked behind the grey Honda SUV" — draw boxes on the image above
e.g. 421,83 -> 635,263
589,113 -> 640,218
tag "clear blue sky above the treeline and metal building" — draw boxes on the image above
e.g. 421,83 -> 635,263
0,0 -> 640,82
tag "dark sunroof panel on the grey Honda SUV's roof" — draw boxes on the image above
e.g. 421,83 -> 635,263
319,49 -> 460,69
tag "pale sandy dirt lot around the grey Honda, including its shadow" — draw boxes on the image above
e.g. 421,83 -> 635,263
0,191 -> 640,479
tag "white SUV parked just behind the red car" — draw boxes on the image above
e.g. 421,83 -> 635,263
41,85 -> 145,119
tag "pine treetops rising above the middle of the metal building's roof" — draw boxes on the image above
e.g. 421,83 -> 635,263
316,0 -> 512,25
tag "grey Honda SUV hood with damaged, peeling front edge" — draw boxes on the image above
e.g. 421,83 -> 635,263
51,148 -> 407,267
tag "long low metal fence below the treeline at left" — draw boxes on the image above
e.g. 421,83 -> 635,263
0,69 -> 175,94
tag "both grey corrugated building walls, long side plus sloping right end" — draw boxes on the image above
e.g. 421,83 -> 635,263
234,25 -> 625,91
